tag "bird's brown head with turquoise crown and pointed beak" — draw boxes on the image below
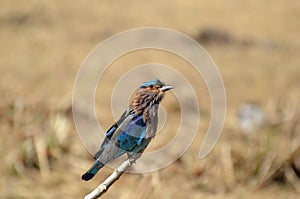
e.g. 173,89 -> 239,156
131,79 -> 174,114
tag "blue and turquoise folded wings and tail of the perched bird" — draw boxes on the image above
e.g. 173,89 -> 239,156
82,111 -> 151,181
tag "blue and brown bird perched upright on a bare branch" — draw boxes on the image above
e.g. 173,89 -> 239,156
82,79 -> 174,181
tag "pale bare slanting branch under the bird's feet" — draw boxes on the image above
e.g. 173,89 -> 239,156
84,156 -> 139,199
